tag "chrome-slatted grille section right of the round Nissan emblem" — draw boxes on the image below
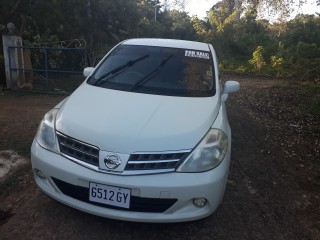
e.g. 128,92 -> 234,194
125,151 -> 189,171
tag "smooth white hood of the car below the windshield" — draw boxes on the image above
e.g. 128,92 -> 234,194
56,83 -> 220,154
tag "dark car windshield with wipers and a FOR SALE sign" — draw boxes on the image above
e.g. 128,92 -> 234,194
88,45 -> 215,97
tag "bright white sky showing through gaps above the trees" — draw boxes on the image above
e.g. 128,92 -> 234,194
165,0 -> 320,19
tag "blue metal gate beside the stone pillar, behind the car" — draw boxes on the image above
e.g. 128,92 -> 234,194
7,41 -> 88,94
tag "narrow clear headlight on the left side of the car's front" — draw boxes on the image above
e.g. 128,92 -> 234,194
36,109 -> 59,153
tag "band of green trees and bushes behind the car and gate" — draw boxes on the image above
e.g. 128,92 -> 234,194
0,0 -> 320,82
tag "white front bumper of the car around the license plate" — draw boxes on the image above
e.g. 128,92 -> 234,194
31,141 -> 230,222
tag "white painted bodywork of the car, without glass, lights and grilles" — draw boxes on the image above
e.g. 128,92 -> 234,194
31,39 -> 239,222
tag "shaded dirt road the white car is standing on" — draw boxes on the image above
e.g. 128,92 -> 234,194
0,79 -> 320,240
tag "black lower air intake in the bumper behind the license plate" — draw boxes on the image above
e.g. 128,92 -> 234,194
52,178 -> 177,213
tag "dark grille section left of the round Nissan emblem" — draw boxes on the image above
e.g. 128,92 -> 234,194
57,132 -> 99,166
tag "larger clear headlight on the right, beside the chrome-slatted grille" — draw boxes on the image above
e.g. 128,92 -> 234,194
177,129 -> 228,172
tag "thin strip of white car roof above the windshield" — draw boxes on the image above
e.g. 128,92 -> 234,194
122,38 -> 210,51
